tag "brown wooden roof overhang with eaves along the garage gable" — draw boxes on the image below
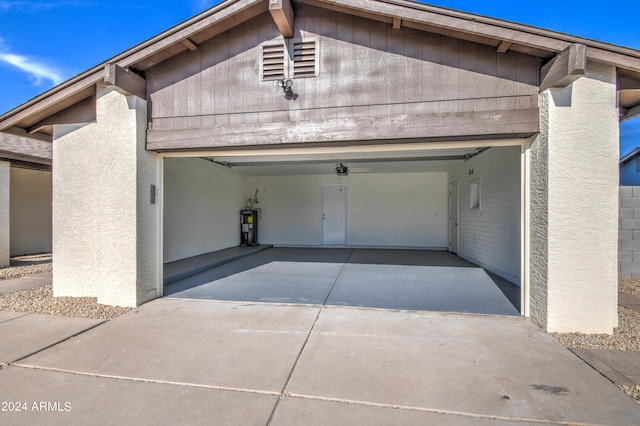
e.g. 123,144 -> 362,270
0,0 -> 640,139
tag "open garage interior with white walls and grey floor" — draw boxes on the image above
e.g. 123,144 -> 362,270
163,140 -> 522,314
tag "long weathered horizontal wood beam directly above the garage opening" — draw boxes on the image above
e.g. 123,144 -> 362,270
147,108 -> 540,151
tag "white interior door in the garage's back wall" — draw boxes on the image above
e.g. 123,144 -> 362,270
322,185 -> 347,245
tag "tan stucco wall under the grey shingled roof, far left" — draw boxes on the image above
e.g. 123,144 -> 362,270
10,167 -> 52,256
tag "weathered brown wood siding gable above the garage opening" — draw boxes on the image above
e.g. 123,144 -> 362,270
147,5 -> 541,151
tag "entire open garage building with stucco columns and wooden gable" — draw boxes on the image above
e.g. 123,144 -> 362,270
0,0 -> 640,333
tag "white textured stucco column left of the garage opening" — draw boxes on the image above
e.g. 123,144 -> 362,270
53,87 -> 161,306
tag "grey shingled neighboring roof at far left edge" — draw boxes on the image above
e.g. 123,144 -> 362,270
0,133 -> 53,170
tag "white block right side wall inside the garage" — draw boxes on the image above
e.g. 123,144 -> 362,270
449,146 -> 521,285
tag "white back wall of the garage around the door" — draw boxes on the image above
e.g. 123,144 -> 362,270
244,172 -> 447,249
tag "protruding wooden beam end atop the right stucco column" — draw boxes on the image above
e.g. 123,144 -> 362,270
540,43 -> 587,92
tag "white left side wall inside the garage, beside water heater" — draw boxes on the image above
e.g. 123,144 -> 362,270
163,158 -> 248,263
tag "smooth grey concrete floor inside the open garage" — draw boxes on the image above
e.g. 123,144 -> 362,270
165,248 -> 520,315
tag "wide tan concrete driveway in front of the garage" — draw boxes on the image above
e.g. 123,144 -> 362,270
0,299 -> 640,425
